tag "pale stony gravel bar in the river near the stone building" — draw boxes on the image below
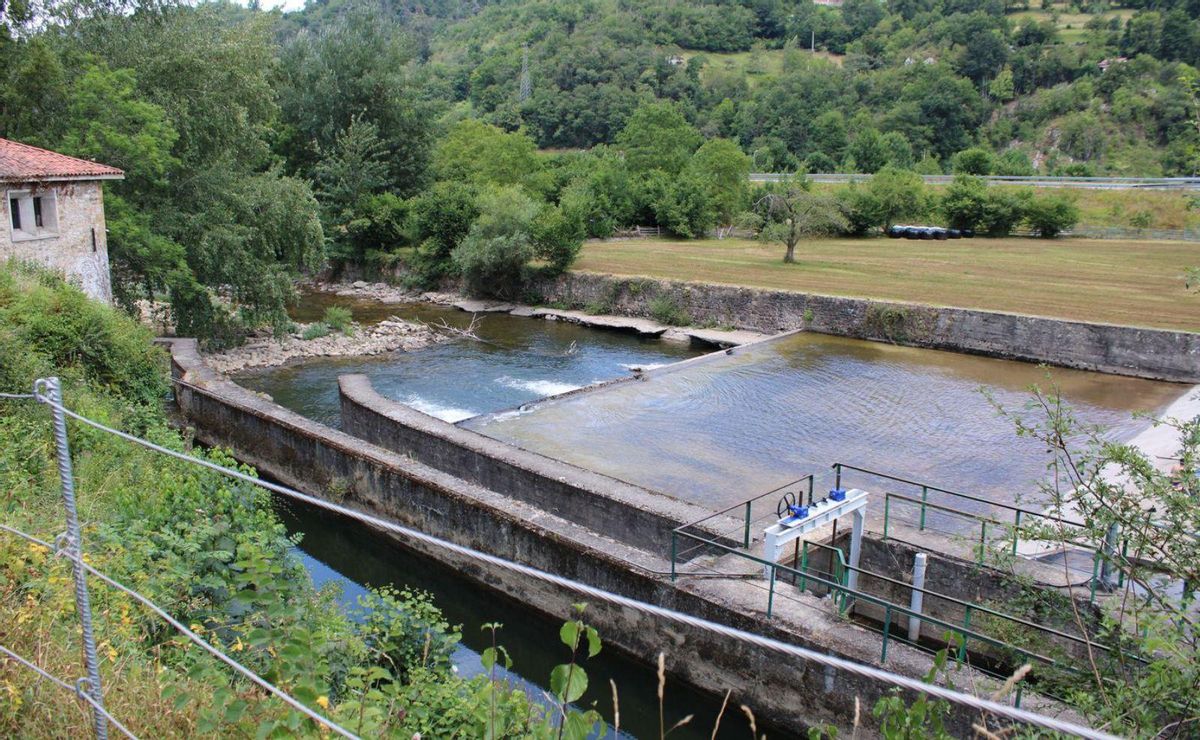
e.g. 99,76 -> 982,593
205,318 -> 446,373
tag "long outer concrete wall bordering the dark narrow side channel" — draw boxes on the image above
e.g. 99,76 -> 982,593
172,339 -> 1060,734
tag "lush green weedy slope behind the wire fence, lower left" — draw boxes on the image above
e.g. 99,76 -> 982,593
0,265 -> 619,739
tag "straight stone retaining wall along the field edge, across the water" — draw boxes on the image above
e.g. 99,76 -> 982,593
536,272 -> 1200,383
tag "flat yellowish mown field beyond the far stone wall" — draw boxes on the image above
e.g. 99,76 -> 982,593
576,237 -> 1200,331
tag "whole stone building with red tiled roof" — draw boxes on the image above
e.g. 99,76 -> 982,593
0,139 -> 125,302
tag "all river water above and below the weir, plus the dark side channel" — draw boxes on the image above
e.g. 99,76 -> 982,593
236,294 -> 1186,738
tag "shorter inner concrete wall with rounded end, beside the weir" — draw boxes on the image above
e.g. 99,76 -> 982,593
338,375 -> 737,553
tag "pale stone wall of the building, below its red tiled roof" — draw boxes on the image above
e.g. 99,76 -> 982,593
0,180 -> 113,303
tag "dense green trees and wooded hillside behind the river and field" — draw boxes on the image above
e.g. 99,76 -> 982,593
0,0 -> 1200,343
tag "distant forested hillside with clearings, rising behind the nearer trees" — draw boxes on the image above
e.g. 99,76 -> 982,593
290,0 -> 1200,175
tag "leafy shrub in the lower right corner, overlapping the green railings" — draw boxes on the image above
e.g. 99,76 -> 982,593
1001,389 -> 1200,738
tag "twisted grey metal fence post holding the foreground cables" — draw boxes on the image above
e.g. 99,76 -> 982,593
34,377 -> 108,740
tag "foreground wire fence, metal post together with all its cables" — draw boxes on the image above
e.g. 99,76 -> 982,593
0,378 -> 1114,739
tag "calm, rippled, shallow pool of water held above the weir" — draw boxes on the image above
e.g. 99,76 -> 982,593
466,333 -> 1186,507
